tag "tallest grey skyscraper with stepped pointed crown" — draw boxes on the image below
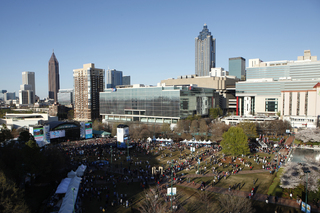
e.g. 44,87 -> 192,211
195,24 -> 216,76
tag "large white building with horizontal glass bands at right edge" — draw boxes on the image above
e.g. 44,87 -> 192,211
236,50 -> 320,122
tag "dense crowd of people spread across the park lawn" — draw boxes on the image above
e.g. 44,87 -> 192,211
48,134 -> 292,211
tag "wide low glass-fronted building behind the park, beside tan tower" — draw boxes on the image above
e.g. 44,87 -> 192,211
100,86 -> 219,123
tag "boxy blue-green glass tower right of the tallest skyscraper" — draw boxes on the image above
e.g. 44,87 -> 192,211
229,57 -> 246,81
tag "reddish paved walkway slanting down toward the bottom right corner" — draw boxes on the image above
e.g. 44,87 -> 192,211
176,181 -> 320,212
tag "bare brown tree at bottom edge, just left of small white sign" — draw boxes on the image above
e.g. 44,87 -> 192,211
139,188 -> 166,213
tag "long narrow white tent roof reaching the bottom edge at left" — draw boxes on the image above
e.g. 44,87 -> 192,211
59,177 -> 81,213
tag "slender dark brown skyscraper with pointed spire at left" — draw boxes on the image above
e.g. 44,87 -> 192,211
48,52 -> 60,101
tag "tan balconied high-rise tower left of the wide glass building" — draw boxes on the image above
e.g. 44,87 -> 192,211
73,63 -> 105,121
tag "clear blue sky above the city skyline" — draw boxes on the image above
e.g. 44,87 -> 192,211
0,0 -> 320,98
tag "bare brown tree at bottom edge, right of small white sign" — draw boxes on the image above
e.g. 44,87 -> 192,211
218,193 -> 255,213
